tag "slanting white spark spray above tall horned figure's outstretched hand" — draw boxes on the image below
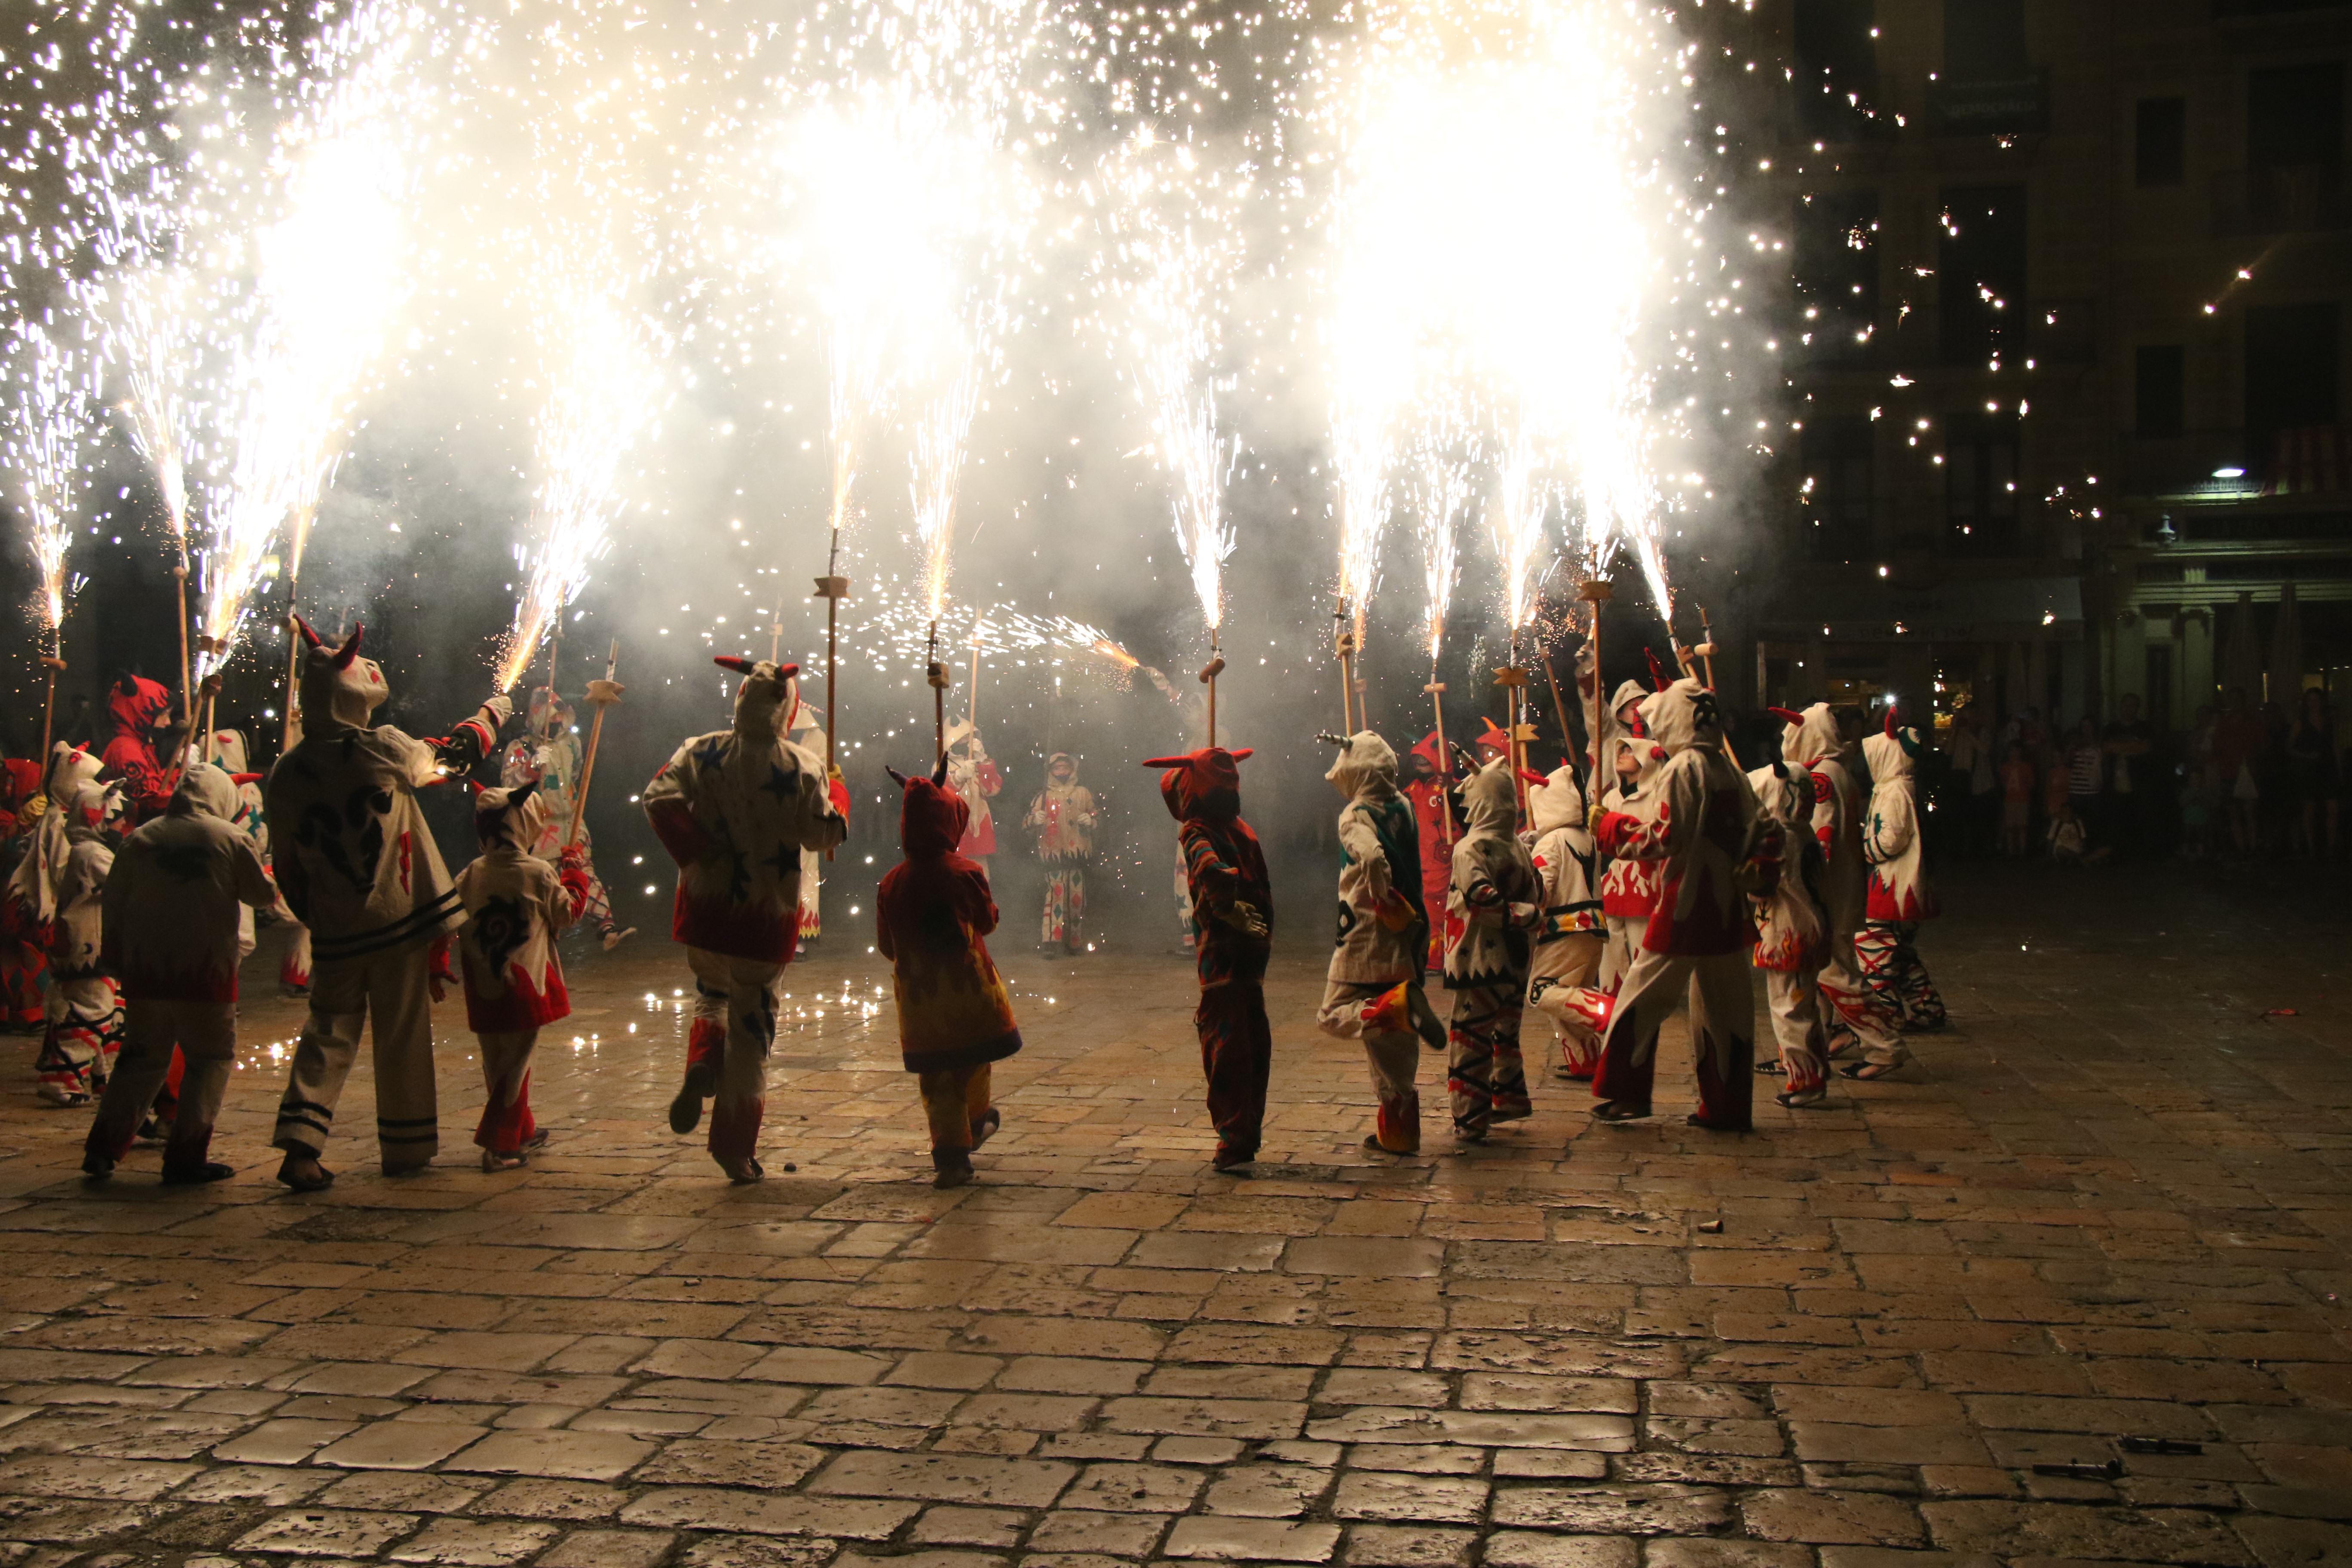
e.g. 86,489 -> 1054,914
494,241 -> 658,691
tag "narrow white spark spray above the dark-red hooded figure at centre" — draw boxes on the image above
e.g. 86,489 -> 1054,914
1103,127 -> 1246,632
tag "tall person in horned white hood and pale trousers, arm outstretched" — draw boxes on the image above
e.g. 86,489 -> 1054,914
266,618 -> 515,1192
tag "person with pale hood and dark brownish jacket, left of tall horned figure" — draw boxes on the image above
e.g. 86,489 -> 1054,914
83,762 -> 278,1185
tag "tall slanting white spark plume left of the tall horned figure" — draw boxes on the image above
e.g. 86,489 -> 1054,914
205,2 -> 416,668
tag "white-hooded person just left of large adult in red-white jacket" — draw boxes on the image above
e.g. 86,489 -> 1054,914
1526,766 -> 1639,1081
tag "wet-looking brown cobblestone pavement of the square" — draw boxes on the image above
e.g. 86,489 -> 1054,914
0,872 -> 2352,1568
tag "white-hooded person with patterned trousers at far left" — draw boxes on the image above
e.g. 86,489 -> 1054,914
33,783 -> 122,1105
